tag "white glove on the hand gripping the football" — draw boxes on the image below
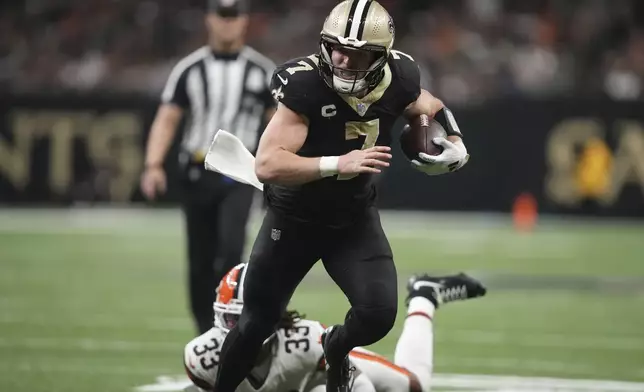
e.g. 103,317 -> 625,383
411,137 -> 470,176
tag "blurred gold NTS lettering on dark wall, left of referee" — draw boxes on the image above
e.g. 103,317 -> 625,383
0,110 -> 143,202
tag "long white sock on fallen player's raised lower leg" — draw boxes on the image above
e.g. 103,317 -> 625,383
394,297 -> 436,390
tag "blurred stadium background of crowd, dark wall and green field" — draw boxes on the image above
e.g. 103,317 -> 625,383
0,0 -> 644,392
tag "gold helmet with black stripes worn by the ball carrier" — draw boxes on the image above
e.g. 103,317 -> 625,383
319,0 -> 395,95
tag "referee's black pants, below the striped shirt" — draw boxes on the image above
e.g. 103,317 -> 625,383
182,163 -> 255,334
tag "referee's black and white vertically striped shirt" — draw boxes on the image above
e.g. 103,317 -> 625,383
161,46 -> 275,157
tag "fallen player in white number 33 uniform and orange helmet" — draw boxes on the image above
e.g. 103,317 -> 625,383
184,264 -> 486,392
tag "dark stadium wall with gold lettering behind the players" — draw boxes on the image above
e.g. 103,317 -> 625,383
0,95 -> 644,217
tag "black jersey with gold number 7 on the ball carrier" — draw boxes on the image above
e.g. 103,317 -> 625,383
264,51 -> 420,225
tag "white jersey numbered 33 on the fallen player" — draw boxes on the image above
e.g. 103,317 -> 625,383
184,320 -> 324,392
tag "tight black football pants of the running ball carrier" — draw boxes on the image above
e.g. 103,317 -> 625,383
215,208 -> 398,392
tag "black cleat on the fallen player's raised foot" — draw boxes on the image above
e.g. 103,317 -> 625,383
406,273 -> 487,308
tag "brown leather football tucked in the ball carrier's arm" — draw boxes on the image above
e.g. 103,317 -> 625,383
400,115 -> 447,161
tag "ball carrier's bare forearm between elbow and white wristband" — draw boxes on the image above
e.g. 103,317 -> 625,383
255,149 -> 322,185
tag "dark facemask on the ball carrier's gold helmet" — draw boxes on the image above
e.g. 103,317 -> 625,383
319,34 -> 388,95
